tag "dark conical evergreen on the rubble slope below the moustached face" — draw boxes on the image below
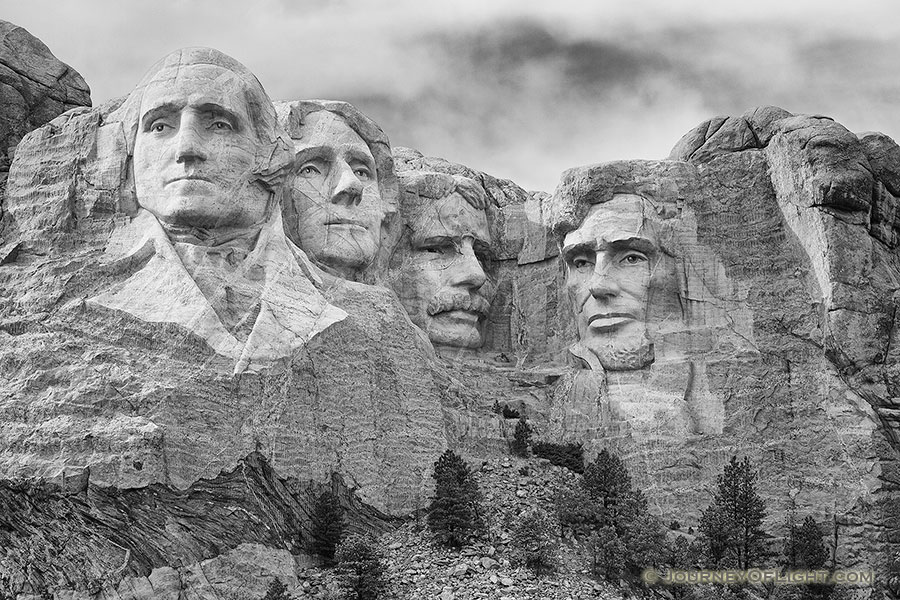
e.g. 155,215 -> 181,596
428,450 -> 481,548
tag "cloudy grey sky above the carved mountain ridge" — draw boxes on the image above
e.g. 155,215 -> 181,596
0,0 -> 900,192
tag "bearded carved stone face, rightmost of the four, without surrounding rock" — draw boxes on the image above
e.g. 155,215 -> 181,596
562,194 -> 659,370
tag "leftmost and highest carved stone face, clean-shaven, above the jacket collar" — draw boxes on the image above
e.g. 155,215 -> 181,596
134,64 -> 270,228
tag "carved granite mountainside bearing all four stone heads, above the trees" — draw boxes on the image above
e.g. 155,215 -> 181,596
0,29 -> 900,600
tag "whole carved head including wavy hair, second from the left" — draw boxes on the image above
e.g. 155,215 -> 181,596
277,101 -> 397,280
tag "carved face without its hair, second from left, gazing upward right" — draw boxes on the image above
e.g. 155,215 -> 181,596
290,110 -> 385,277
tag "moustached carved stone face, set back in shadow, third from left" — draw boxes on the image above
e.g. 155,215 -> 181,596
398,193 -> 496,348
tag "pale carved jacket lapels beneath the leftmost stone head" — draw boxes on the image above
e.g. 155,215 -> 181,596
87,209 -> 347,374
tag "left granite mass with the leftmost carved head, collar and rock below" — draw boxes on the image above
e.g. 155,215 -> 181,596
0,44 -> 448,598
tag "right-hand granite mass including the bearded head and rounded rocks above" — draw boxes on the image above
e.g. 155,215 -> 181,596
543,108 -> 900,584
